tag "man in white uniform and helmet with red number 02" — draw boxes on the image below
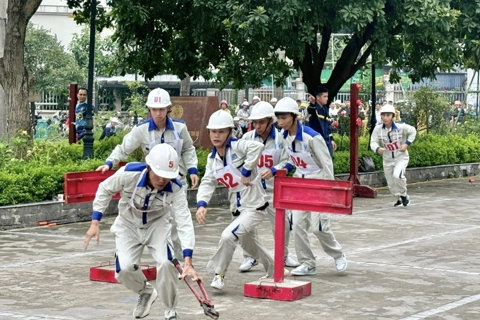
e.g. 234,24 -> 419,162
196,110 -> 273,290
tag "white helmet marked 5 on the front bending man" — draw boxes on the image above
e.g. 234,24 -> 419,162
145,144 -> 179,179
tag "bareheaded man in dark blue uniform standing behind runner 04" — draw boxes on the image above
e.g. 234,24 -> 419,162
307,86 -> 337,159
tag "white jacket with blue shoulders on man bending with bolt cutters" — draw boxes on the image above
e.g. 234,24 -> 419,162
93,162 -> 195,257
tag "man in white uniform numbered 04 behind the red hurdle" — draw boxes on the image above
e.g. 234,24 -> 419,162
275,97 -> 347,276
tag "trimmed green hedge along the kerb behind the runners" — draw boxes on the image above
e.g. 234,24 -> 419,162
0,134 -> 480,206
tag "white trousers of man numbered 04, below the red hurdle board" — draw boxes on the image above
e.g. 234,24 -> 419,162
292,210 -> 342,267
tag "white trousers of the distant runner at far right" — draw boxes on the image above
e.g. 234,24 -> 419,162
383,151 -> 410,197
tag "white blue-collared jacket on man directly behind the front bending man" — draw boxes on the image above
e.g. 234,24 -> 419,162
105,117 -> 198,176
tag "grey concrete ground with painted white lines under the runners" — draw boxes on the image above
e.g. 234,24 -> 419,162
0,178 -> 480,320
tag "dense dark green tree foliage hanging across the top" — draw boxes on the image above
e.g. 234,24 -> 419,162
67,0 -> 480,96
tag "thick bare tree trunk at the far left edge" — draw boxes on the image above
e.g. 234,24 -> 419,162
0,0 -> 42,139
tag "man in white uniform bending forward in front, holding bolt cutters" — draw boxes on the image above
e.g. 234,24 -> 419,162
84,144 -> 199,320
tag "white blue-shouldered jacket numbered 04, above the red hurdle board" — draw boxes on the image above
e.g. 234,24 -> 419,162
283,121 -> 335,180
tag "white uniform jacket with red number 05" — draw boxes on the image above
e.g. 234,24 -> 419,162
242,124 -> 288,195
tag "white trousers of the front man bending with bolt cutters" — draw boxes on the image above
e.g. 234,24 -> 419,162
110,214 -> 179,309
